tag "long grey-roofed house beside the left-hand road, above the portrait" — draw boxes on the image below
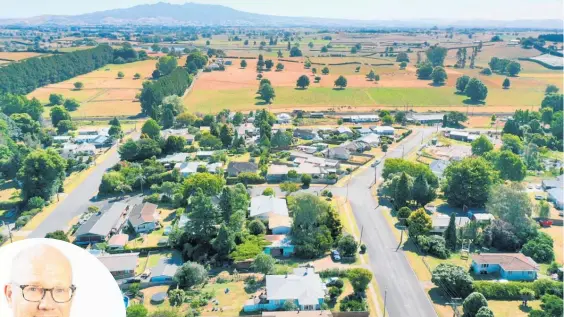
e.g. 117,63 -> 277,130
74,202 -> 130,245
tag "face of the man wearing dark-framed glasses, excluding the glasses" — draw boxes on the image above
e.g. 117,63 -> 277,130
4,246 -> 72,317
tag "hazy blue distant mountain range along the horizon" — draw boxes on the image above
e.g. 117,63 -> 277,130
0,2 -> 562,30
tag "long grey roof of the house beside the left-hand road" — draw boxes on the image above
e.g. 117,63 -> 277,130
75,202 -> 128,237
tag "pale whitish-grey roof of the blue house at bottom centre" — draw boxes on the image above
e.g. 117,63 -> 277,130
266,268 -> 325,306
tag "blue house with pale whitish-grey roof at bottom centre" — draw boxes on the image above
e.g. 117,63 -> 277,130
243,267 -> 327,312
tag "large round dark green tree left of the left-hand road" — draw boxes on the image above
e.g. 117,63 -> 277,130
18,149 -> 67,201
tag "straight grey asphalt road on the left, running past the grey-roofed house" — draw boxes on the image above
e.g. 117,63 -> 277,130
27,133 -> 139,238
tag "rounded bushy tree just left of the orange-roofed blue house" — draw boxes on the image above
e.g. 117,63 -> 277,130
431,263 -> 474,297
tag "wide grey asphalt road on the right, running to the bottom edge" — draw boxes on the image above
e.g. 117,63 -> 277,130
339,128 -> 437,317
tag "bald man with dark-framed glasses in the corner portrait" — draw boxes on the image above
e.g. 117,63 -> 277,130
4,244 -> 76,317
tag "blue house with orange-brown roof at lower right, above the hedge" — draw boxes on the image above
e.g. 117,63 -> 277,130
472,253 -> 539,281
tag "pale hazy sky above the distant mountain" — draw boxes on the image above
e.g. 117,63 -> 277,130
0,0 -> 564,20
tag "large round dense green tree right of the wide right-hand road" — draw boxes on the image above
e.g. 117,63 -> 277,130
443,157 -> 497,207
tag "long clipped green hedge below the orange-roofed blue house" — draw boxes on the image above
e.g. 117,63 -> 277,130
474,279 -> 564,300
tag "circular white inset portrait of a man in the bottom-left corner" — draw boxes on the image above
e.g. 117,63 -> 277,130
0,239 -> 125,317
